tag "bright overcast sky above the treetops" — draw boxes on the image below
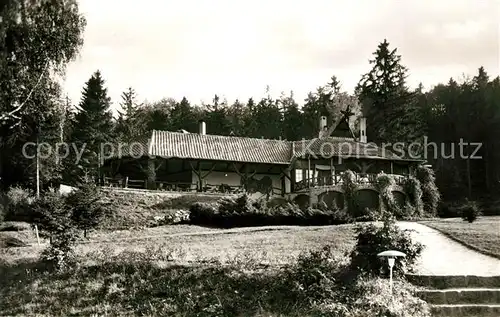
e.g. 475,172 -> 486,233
65,0 -> 500,109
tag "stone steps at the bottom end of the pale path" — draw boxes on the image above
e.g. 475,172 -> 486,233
407,272 -> 500,317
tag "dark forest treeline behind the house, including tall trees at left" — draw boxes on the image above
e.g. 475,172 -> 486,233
0,0 -> 500,200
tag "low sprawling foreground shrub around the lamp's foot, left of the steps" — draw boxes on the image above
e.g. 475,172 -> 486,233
286,246 -> 430,317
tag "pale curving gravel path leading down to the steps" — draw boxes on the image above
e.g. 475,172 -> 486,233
398,222 -> 500,276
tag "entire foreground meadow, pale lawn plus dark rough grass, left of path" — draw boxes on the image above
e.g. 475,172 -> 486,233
0,224 -> 428,317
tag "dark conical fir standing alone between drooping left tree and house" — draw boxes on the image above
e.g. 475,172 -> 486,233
72,70 -> 113,181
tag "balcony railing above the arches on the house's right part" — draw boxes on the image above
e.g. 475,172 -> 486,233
294,173 -> 407,191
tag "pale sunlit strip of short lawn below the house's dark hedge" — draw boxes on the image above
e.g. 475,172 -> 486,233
0,225 -> 355,265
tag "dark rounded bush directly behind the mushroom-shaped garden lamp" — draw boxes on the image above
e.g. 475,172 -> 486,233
351,218 -> 423,275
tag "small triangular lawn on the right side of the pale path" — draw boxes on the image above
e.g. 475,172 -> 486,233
421,216 -> 500,258
